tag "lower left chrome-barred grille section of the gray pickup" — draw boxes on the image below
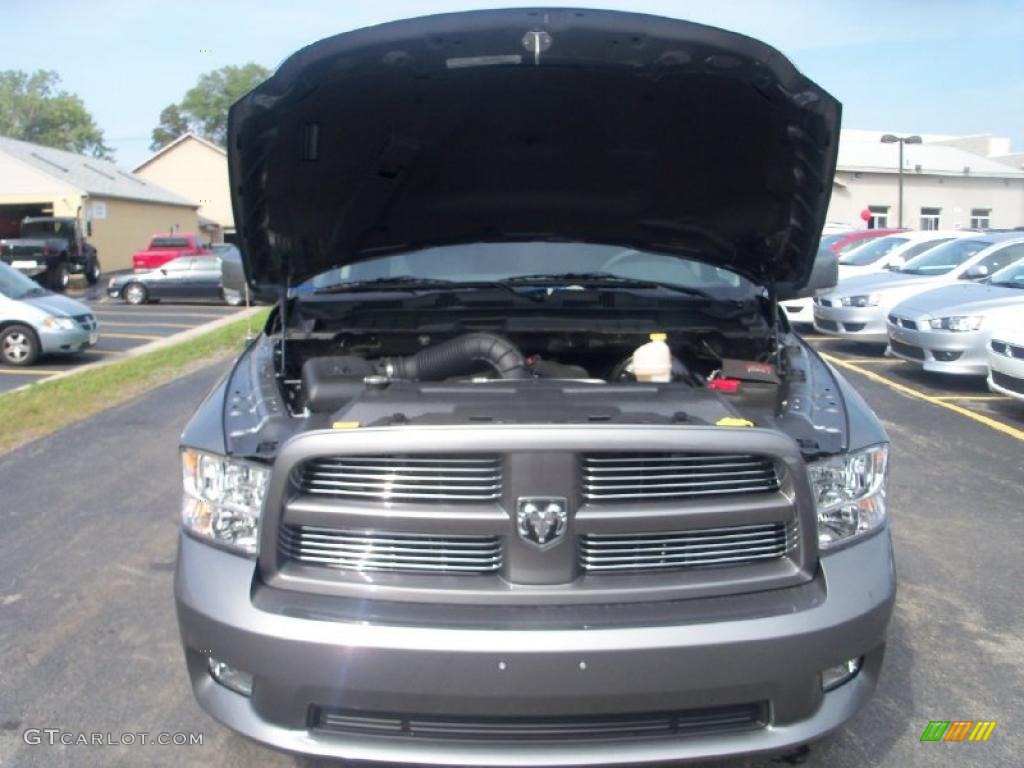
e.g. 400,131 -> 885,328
279,525 -> 502,574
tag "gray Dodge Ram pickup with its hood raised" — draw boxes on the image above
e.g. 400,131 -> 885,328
175,8 -> 896,766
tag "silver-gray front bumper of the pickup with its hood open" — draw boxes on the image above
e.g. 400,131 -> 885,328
175,529 -> 895,766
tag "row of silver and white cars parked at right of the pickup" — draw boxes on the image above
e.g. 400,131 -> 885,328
787,231 -> 1024,399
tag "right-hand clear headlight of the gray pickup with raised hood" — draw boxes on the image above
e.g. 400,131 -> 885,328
807,444 -> 889,549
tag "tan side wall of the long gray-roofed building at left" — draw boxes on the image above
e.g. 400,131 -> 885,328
88,197 -> 199,272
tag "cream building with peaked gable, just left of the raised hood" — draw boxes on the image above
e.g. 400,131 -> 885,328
134,132 -> 234,243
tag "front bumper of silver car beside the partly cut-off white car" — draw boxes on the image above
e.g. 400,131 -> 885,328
886,323 -> 989,376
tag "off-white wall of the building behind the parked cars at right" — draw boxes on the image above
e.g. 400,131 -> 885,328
828,171 -> 1024,229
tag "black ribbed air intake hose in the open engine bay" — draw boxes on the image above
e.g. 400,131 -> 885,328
384,334 -> 530,381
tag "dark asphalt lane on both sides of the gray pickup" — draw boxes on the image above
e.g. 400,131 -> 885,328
0,342 -> 1024,768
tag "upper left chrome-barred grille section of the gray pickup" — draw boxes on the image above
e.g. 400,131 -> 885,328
296,455 -> 502,503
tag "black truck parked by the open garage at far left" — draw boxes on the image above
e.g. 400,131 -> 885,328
0,216 -> 102,291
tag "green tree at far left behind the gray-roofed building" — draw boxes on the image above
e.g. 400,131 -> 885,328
0,70 -> 113,159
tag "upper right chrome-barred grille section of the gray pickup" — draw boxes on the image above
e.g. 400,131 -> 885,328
582,454 -> 778,502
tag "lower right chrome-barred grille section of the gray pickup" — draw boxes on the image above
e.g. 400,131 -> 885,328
580,521 -> 798,572
